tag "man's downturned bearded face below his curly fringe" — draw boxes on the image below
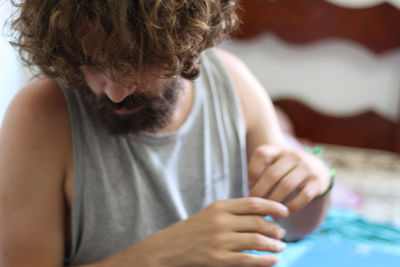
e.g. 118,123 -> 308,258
80,66 -> 182,135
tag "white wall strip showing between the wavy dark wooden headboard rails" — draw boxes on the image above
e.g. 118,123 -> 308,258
222,35 -> 400,120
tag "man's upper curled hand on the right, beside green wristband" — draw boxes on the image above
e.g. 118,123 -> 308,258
248,145 -> 330,212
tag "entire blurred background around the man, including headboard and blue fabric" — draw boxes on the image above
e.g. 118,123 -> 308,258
0,0 -> 400,267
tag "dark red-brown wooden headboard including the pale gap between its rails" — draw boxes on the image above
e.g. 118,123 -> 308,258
222,0 -> 400,153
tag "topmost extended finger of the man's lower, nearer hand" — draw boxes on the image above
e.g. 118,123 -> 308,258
208,197 -> 289,218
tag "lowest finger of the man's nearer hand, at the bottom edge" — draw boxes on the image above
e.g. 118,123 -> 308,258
226,252 -> 278,267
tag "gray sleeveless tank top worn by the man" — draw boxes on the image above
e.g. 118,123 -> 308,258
62,49 -> 247,266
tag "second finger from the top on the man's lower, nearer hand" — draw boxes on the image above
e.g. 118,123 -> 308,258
231,216 -> 286,239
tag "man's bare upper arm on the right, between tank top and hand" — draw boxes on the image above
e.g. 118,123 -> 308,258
217,49 -> 283,154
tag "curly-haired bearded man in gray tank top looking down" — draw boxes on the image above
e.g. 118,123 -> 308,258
0,0 -> 330,267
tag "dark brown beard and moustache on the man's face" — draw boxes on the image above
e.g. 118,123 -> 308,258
79,78 -> 183,135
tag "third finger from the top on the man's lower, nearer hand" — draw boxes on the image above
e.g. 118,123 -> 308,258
227,233 -> 286,253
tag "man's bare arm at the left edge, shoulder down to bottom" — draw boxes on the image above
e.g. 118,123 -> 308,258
0,78 -> 70,266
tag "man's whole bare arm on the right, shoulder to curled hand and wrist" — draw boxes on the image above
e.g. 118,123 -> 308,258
218,50 -> 330,239
